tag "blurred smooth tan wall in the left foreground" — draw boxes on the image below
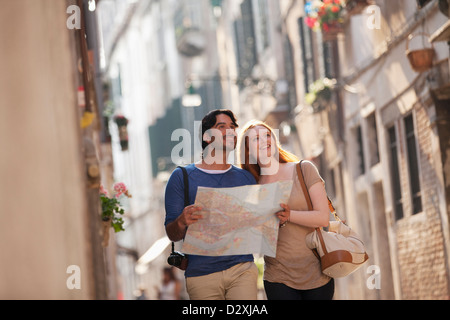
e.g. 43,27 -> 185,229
0,0 -> 94,299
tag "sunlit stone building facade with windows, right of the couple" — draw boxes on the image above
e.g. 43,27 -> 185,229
281,1 -> 450,299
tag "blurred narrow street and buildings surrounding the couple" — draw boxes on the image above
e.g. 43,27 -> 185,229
0,0 -> 450,299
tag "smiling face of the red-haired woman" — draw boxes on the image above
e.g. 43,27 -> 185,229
248,126 -> 276,165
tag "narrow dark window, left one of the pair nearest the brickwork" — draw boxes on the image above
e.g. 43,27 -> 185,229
388,126 -> 403,220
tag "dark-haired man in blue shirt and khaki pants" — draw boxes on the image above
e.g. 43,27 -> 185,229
165,109 -> 258,300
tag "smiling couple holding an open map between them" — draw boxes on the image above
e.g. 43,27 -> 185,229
165,109 -> 334,300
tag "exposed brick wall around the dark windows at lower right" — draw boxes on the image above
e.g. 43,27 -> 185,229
396,104 -> 449,299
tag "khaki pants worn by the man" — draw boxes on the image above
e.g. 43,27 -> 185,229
186,262 -> 258,300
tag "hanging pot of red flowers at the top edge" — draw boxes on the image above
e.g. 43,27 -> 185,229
305,0 -> 345,41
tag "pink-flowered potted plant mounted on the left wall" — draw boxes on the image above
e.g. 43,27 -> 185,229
100,182 -> 131,247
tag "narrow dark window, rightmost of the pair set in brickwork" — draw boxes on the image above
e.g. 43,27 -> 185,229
404,114 -> 422,214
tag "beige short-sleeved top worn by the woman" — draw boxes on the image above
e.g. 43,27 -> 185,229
264,161 -> 330,290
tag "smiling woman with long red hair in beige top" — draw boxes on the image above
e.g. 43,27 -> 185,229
238,121 -> 334,300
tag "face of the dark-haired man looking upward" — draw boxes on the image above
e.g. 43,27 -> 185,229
203,113 -> 237,151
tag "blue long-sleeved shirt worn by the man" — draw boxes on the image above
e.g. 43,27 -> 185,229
164,164 -> 256,277
